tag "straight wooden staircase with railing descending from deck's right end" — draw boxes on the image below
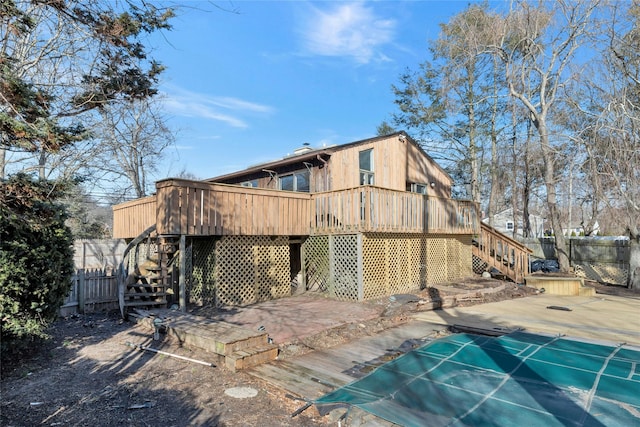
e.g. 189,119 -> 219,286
473,223 -> 533,283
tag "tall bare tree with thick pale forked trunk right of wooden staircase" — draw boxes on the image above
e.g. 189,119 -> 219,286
499,0 -> 599,271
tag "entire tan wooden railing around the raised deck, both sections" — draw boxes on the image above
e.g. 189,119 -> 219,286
114,179 -> 479,238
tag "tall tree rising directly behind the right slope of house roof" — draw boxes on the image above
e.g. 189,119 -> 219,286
393,5 -> 504,206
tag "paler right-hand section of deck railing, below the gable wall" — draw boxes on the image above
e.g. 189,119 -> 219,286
312,186 -> 479,234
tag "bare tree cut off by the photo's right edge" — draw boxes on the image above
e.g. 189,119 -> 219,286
578,1 -> 640,290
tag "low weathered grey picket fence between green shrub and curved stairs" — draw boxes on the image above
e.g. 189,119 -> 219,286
60,269 -> 118,316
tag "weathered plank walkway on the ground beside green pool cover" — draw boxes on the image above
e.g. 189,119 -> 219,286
246,321 -> 446,400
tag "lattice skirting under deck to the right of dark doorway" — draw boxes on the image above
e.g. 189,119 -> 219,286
303,233 -> 473,301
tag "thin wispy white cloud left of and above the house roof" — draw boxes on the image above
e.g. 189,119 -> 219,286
164,87 -> 273,128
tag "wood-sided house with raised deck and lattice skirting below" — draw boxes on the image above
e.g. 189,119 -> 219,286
113,132 -> 528,316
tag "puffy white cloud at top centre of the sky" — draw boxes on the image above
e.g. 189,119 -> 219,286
299,2 -> 396,64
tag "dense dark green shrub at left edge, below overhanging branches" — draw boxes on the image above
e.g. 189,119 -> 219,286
0,174 -> 73,350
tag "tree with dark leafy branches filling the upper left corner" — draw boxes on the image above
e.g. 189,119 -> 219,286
0,0 -> 173,178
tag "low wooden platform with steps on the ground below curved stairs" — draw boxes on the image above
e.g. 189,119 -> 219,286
130,309 -> 278,372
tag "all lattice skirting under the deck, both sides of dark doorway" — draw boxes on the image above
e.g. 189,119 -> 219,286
186,233 -> 472,306
